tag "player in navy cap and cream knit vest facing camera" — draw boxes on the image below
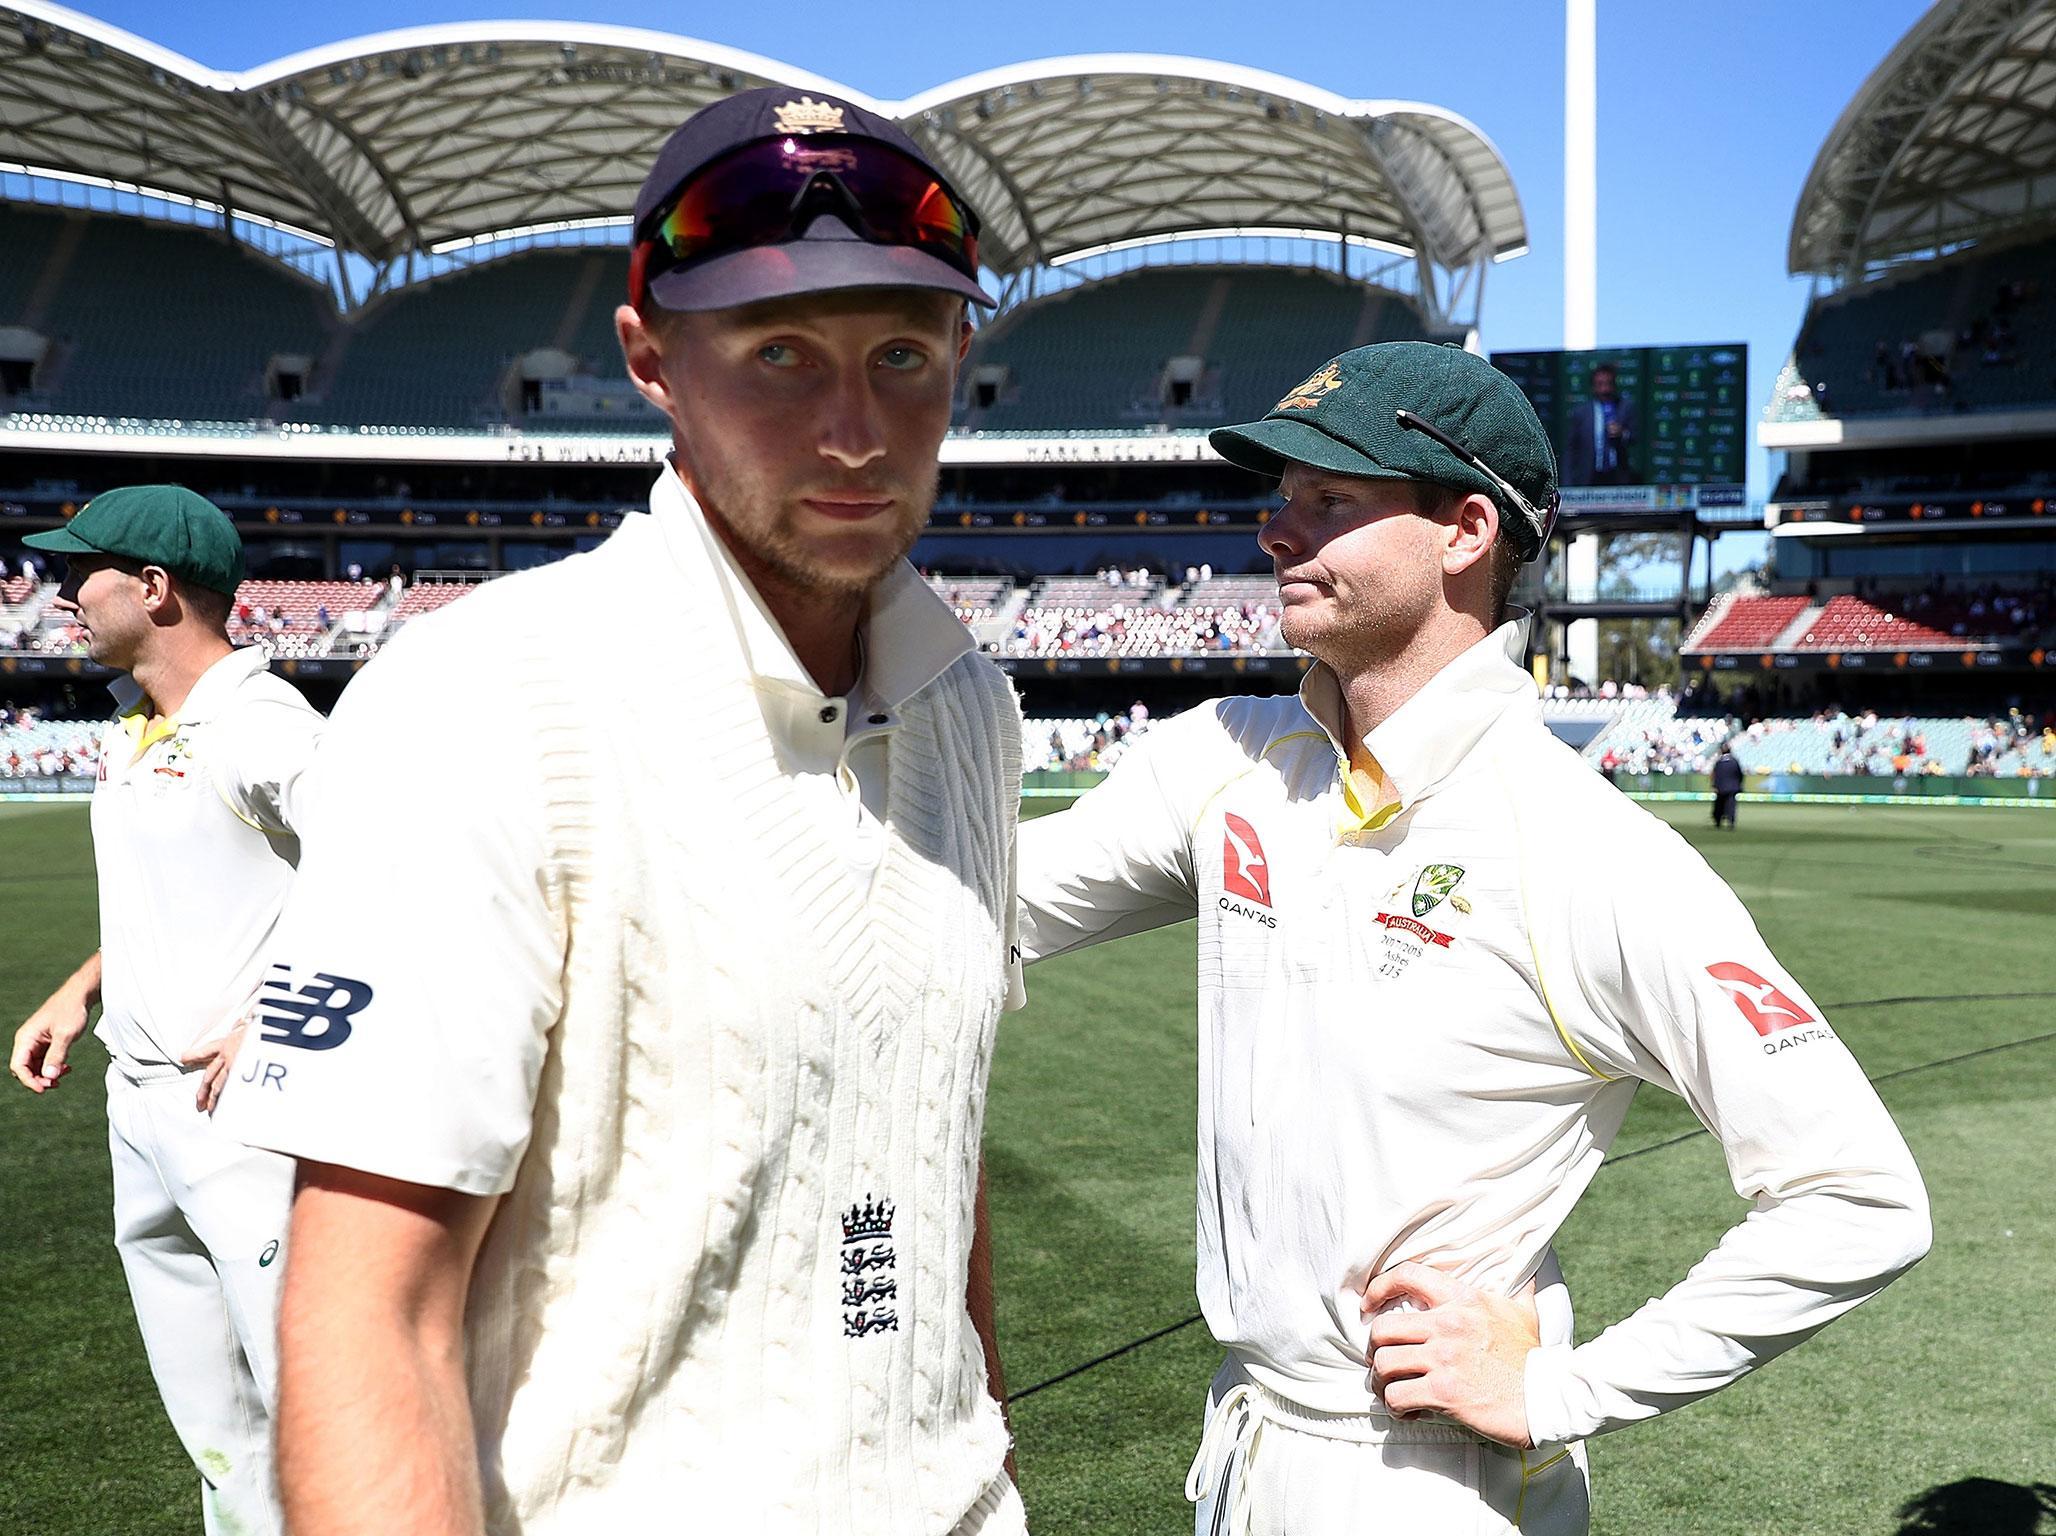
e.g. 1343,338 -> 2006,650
222,88 -> 1024,1536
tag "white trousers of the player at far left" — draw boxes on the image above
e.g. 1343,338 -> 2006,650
107,1065 -> 292,1536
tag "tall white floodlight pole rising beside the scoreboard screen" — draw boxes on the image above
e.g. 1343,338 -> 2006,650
1563,0 -> 1600,687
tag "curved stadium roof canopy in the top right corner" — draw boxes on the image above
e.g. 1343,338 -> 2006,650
1787,0 -> 2056,282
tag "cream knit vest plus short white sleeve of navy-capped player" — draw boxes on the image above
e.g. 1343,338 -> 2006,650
222,504 -> 1020,1536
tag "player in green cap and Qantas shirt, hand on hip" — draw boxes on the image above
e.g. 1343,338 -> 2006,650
1020,341 -> 1929,1536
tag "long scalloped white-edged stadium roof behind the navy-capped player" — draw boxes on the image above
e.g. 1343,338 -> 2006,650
0,0 -> 1528,308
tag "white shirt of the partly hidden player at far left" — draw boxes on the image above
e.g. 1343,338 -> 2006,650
93,646 -> 323,1067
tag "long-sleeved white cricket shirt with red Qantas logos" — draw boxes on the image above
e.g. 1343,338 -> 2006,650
1020,621 -> 1929,1443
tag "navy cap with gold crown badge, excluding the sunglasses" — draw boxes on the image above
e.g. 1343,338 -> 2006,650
633,86 -> 995,310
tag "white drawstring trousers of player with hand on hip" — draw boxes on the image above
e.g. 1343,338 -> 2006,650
1184,1355 -> 1591,1536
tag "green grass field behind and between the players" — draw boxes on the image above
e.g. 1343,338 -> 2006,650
0,804 -> 2056,1536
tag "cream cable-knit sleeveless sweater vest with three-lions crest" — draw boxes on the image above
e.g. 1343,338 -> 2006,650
469,539 -> 1020,1536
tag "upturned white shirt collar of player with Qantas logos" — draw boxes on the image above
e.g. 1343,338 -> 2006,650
1299,613 -> 1536,808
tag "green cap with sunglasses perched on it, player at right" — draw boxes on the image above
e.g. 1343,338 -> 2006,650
1207,341 -> 1556,557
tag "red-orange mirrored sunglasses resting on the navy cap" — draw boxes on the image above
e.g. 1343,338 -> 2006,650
629,134 -> 979,308
